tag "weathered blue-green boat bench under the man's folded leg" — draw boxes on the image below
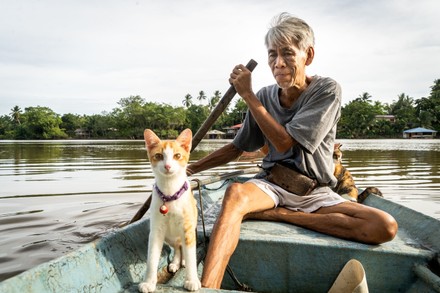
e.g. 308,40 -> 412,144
224,221 -> 435,292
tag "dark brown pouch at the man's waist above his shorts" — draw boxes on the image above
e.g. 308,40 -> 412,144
266,163 -> 318,196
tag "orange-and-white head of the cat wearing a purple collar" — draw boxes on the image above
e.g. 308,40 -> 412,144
144,129 -> 192,176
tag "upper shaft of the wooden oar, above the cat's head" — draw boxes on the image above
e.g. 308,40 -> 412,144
191,59 -> 258,152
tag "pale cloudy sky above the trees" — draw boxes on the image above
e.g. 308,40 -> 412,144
0,0 -> 440,115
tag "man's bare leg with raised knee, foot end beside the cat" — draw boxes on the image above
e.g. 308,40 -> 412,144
202,183 -> 275,288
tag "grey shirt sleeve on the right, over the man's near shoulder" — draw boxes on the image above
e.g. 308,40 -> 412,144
286,81 -> 341,154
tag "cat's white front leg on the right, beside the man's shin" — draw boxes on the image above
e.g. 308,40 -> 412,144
182,230 -> 202,291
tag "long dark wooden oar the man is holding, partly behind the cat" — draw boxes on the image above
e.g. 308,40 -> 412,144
128,59 -> 258,224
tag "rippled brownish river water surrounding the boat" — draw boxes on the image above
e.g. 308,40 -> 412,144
0,139 -> 440,281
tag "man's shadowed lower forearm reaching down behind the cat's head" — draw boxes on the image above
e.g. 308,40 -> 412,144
186,143 -> 243,175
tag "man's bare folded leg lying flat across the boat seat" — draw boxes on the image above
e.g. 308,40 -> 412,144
246,202 -> 398,244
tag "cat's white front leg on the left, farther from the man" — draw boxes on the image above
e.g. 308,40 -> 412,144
138,228 -> 165,293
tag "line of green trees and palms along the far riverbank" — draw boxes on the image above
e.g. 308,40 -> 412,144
0,79 -> 440,139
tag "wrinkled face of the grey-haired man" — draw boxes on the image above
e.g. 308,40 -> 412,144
268,44 -> 307,89
